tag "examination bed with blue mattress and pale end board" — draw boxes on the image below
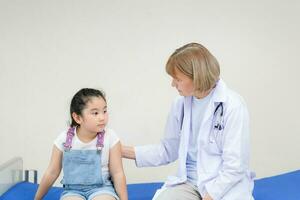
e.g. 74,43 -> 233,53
0,158 -> 300,200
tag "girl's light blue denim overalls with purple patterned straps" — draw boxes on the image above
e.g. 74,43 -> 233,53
61,127 -> 119,200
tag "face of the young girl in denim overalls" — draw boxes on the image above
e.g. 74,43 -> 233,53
75,97 -> 108,133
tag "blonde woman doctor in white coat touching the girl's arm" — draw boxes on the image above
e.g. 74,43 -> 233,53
122,43 -> 254,200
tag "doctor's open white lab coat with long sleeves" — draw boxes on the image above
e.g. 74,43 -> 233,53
135,80 -> 254,200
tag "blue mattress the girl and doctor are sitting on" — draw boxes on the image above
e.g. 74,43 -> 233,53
0,170 -> 300,200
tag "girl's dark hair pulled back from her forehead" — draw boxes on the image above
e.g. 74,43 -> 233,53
70,88 -> 106,127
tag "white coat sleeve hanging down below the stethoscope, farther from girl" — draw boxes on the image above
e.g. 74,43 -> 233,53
205,104 -> 250,200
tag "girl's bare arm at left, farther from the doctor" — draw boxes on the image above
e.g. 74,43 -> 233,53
34,145 -> 62,200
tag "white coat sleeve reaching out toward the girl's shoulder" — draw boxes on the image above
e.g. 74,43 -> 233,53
134,98 -> 183,167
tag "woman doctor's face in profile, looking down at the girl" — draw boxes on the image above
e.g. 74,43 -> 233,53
172,68 -> 194,96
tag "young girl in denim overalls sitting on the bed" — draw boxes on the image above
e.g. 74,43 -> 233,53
35,88 -> 128,200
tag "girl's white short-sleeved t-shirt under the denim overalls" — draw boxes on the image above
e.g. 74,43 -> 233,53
54,129 -> 120,173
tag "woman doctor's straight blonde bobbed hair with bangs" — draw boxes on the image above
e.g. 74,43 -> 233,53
166,43 -> 220,92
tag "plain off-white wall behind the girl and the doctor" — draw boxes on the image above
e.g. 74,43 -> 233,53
0,0 -> 300,182
